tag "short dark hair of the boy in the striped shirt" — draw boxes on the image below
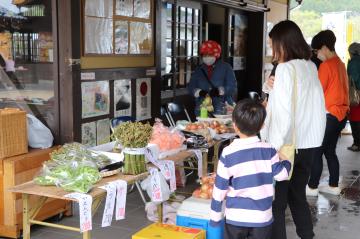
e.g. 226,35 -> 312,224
232,99 -> 266,136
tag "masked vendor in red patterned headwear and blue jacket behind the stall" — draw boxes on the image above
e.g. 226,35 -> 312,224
187,40 -> 236,116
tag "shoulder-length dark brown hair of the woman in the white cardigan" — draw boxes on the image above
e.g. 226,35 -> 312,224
269,20 -> 311,62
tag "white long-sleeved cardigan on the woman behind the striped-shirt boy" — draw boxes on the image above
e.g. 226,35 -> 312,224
260,60 -> 326,149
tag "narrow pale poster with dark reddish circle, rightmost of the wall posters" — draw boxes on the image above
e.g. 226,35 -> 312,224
136,78 -> 151,120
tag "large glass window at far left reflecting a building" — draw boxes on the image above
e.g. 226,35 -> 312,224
0,0 -> 58,134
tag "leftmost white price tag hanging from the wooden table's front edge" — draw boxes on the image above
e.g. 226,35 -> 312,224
65,193 -> 92,232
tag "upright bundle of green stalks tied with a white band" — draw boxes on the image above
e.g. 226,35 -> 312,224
111,122 -> 153,175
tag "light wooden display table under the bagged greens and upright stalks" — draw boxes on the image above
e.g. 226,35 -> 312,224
10,172 -> 149,239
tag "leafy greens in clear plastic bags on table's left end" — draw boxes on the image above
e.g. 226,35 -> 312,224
34,143 -> 110,193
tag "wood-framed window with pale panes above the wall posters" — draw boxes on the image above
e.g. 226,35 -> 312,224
84,0 -> 153,55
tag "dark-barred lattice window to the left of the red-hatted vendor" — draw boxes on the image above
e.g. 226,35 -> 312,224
161,3 -> 200,90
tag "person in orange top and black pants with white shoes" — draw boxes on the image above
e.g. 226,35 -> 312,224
306,30 -> 349,196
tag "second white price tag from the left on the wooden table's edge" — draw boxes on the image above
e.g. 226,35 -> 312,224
100,183 -> 116,227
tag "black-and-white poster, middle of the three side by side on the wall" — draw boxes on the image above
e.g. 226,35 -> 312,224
114,79 -> 131,117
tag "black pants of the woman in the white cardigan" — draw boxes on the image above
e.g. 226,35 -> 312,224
271,147 -> 320,239
